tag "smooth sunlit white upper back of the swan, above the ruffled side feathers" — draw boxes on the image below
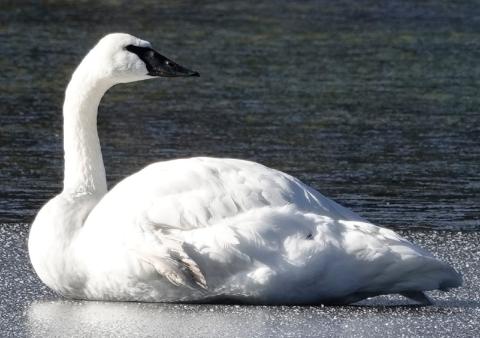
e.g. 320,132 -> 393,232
86,157 -> 363,234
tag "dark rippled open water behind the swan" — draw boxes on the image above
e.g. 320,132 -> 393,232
0,0 -> 480,230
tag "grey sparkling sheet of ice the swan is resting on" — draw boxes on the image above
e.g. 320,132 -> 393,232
0,224 -> 480,337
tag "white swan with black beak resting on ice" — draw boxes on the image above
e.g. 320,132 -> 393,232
28,33 -> 462,304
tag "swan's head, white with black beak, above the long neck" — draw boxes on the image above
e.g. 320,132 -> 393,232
84,33 -> 199,83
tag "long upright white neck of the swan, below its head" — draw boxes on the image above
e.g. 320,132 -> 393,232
63,60 -> 112,196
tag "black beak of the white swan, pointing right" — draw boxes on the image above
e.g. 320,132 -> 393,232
125,45 -> 200,77
